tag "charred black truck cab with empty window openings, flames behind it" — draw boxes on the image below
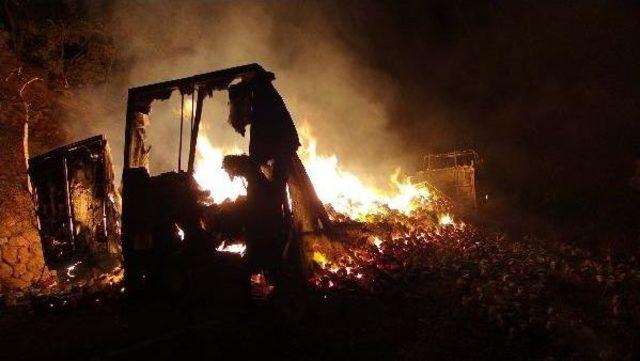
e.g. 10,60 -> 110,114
122,64 -> 340,296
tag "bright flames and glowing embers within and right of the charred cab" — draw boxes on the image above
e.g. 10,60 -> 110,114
194,122 -> 466,288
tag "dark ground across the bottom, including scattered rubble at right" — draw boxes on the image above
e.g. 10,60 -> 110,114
0,219 -> 640,360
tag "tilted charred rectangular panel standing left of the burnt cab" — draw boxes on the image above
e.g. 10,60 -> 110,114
29,135 -> 120,282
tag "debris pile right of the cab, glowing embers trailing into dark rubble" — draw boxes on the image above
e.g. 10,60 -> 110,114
310,188 -> 640,359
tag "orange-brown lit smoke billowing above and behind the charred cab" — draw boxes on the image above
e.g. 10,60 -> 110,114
63,1 -> 409,188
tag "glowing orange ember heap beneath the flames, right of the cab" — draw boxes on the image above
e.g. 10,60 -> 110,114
310,201 -> 460,292
